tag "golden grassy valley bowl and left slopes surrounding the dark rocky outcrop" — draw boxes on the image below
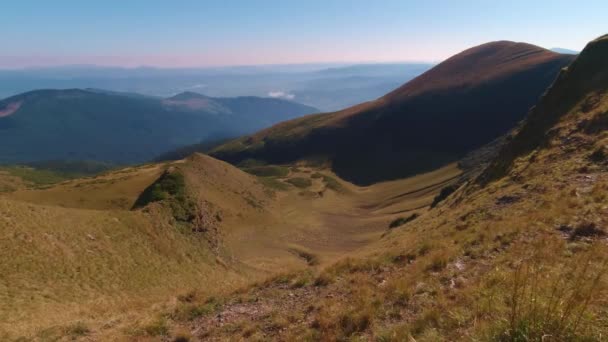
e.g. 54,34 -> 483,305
0,155 -> 460,340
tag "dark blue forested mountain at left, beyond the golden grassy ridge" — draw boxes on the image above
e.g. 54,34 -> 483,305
0,89 -> 318,163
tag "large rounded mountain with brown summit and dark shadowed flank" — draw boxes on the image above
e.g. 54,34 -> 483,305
212,41 -> 575,184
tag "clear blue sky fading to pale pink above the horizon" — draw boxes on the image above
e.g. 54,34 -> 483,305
0,0 -> 608,68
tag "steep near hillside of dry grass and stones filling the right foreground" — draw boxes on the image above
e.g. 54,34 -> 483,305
154,37 -> 608,341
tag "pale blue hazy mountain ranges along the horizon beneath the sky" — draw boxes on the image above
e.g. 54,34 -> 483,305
0,63 -> 431,111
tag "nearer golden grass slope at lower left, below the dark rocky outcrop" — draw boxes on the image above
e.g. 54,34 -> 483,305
0,199 -> 243,338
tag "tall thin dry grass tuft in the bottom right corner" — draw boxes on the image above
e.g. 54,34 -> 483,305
491,253 -> 607,341
